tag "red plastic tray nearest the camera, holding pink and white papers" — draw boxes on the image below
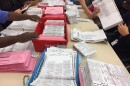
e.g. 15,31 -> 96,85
33,16 -> 68,52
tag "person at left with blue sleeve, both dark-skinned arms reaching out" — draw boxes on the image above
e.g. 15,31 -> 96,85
0,10 -> 41,48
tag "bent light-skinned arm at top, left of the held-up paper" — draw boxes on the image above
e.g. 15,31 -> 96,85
78,0 -> 100,19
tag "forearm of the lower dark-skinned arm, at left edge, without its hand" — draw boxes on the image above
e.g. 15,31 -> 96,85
0,36 -> 19,48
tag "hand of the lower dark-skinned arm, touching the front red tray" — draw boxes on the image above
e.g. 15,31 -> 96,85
16,32 -> 38,43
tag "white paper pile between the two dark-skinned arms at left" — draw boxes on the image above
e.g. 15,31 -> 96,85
7,20 -> 38,31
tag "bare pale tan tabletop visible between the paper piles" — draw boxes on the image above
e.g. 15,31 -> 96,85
0,10 -> 130,86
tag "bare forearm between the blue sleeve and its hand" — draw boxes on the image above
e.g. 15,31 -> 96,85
8,12 -> 30,21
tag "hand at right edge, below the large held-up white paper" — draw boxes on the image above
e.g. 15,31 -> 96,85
118,24 -> 129,36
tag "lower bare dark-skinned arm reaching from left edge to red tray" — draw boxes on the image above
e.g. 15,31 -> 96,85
0,32 -> 38,48
